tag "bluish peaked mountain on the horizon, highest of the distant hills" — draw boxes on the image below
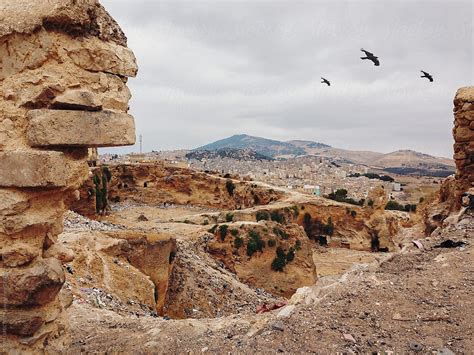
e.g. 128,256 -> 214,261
194,134 -> 306,158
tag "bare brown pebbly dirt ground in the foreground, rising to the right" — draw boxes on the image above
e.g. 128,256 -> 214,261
64,215 -> 474,354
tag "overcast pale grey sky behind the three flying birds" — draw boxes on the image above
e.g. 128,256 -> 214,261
101,0 -> 474,157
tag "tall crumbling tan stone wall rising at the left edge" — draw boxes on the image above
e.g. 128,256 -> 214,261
0,0 -> 137,352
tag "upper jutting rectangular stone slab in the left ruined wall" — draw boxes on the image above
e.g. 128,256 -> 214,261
27,110 -> 135,147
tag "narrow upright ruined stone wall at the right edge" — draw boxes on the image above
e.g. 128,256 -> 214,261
453,86 -> 474,207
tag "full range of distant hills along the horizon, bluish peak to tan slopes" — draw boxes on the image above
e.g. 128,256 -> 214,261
195,134 -> 455,177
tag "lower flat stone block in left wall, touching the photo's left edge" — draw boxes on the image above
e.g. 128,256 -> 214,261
0,151 -> 87,187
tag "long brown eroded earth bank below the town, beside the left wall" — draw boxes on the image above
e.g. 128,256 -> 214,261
71,162 -> 283,217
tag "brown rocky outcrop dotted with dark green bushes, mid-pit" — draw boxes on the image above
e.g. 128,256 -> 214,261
207,221 -> 317,297
